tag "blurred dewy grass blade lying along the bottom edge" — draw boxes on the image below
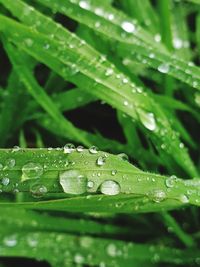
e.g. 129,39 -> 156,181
0,230 -> 199,267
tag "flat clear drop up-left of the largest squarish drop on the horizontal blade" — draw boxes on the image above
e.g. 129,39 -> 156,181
22,162 -> 44,181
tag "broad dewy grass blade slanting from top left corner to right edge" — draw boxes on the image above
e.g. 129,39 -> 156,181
0,1 -> 198,179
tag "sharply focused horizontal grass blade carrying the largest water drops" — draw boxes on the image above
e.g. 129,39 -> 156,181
0,148 -> 200,212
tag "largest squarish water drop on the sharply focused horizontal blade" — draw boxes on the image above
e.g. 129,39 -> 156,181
59,170 -> 88,195
